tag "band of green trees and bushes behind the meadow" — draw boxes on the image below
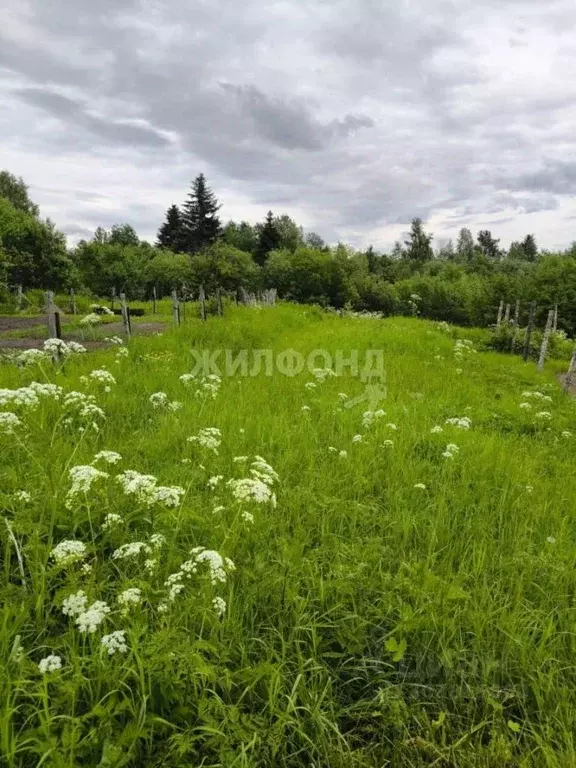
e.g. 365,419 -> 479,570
0,171 -> 576,333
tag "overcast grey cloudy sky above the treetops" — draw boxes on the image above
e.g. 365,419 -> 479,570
0,0 -> 576,248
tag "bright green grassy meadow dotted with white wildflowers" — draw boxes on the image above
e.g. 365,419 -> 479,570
0,305 -> 576,768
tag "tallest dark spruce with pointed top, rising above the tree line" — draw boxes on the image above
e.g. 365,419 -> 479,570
182,173 -> 222,253
